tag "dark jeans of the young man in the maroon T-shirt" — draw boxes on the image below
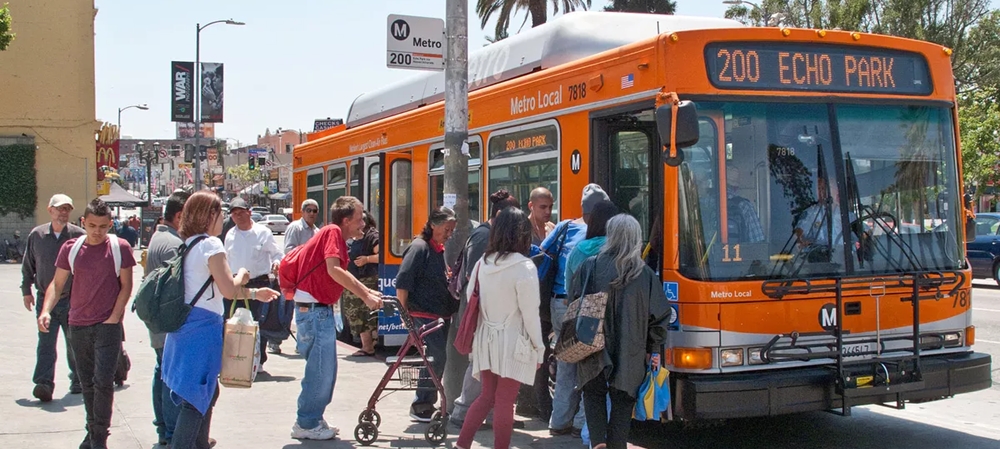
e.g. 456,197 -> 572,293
70,324 -> 122,448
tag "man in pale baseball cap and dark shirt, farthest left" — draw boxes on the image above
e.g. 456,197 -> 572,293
21,193 -> 84,402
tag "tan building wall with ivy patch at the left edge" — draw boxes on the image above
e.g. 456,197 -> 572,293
0,0 -> 99,237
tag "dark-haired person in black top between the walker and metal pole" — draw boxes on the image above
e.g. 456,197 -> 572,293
396,207 -> 458,422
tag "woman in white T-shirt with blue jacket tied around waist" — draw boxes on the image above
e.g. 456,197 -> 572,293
162,190 -> 278,449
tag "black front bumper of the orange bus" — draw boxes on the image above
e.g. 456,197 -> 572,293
674,352 -> 992,421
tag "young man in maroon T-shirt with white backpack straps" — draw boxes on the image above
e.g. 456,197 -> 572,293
38,199 -> 135,449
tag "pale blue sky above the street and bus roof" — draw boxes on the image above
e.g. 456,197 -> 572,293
94,0 -> 726,145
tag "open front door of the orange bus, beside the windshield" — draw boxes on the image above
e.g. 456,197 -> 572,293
591,105 -> 663,271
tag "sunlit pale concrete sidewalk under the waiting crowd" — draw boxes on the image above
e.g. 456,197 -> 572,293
0,256 -> 584,449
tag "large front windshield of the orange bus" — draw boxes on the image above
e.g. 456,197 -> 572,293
678,102 -> 962,280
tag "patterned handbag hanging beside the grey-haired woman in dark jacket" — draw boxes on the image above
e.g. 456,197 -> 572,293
555,269 -> 608,363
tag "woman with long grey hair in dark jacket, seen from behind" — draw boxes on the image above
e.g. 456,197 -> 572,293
569,214 -> 672,449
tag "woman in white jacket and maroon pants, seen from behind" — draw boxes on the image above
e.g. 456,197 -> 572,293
455,207 -> 545,449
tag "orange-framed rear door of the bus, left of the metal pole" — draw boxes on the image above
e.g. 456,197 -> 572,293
376,151 -> 414,346
